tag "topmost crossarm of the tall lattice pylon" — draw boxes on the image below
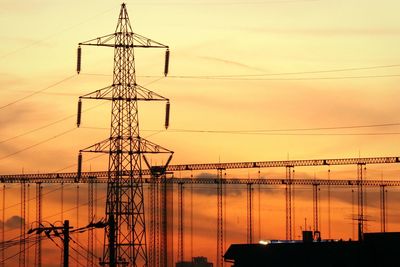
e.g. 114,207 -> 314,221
79,32 -> 168,48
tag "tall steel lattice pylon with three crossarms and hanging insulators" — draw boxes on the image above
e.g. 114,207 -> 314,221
77,4 -> 172,266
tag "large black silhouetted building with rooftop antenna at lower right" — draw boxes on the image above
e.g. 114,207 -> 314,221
224,233 -> 400,267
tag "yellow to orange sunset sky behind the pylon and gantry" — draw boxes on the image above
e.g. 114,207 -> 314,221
0,0 -> 400,266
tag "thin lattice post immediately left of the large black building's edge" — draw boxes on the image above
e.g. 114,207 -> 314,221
216,168 -> 224,267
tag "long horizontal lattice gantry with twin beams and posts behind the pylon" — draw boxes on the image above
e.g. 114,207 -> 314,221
0,157 -> 400,266
